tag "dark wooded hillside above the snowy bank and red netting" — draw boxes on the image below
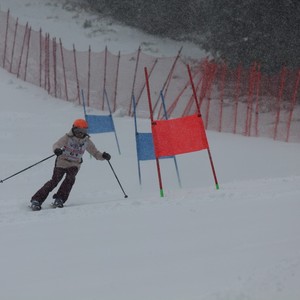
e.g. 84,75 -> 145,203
81,0 -> 300,72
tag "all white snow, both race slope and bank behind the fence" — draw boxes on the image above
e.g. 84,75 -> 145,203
0,0 -> 300,300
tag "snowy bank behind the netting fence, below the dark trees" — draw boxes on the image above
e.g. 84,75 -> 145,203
0,0 -> 207,59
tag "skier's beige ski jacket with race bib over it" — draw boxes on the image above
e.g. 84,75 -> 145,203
53,130 -> 104,169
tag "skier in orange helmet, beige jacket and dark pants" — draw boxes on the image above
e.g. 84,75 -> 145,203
31,119 -> 111,210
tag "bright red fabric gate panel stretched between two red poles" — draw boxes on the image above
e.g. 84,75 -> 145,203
151,115 -> 209,157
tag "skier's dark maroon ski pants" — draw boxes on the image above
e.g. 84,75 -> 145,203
31,167 -> 78,204
